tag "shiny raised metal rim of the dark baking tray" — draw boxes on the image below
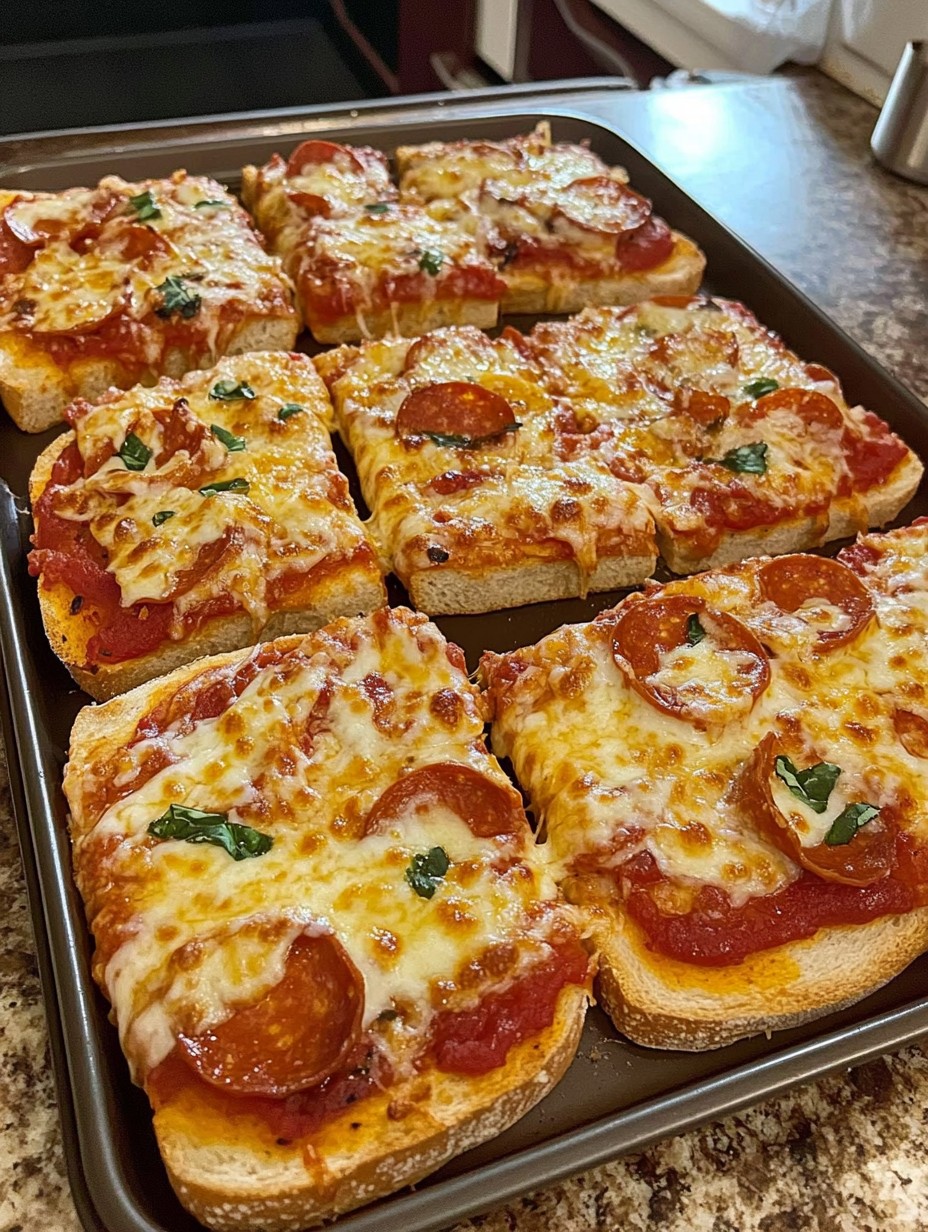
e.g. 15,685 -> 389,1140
0,81 -> 928,1232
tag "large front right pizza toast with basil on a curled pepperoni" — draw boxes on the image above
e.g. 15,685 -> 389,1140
482,521 -> 928,1048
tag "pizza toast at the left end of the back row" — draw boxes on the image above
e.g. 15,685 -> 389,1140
0,171 -> 299,432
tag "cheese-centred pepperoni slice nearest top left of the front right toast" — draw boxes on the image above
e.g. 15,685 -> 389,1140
613,595 -> 770,728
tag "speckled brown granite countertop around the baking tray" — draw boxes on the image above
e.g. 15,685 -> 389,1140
0,64 -> 928,1232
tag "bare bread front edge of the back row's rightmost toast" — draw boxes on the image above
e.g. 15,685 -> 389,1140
500,232 -> 706,314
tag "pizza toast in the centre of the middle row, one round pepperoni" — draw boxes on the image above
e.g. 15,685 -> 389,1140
317,326 -> 657,614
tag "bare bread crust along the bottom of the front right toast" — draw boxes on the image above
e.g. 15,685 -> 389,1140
590,906 -> 928,1052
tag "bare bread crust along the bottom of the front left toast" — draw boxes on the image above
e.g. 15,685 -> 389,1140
154,988 -> 585,1232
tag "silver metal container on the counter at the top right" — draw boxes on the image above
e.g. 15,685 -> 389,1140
870,42 -> 928,184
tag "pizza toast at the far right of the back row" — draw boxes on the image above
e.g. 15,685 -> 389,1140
397,121 -> 706,313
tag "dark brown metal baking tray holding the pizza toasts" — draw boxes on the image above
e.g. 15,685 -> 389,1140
0,83 -> 928,1232
